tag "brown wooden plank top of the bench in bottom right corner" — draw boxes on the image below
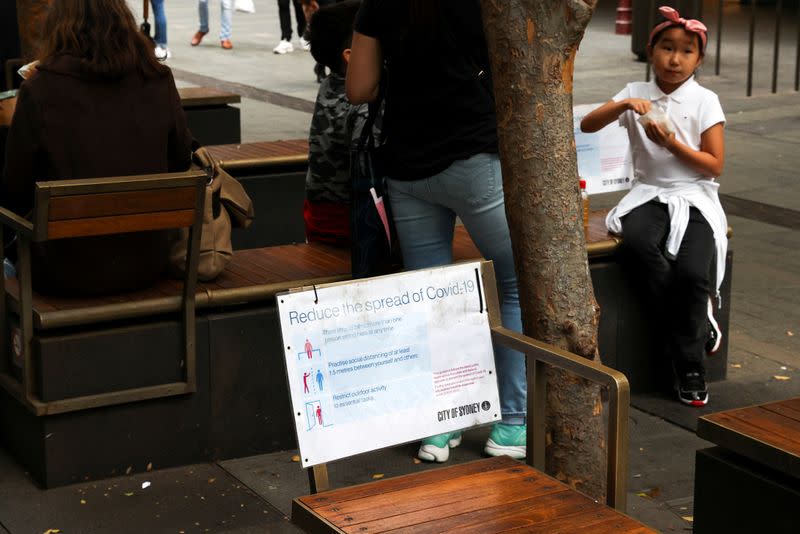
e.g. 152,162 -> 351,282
697,397 -> 800,479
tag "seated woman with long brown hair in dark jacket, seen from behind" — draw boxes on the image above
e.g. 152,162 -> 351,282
0,0 -> 192,295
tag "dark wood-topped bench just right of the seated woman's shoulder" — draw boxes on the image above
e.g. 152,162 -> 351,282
178,87 -> 242,145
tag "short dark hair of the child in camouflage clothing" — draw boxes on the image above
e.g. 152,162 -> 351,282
308,0 -> 361,74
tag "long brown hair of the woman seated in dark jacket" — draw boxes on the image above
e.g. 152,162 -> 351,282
39,0 -> 169,78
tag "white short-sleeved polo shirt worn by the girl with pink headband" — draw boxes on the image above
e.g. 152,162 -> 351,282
613,76 -> 725,187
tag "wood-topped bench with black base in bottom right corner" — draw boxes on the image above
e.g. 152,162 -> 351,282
694,397 -> 800,534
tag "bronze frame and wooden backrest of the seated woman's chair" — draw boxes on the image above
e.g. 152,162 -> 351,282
0,171 -> 208,416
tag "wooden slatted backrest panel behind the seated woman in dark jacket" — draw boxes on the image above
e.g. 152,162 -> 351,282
33,171 -> 206,241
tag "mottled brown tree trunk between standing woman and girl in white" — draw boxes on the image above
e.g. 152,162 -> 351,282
481,0 -> 606,500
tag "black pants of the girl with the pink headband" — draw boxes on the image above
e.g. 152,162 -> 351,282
621,201 -> 715,372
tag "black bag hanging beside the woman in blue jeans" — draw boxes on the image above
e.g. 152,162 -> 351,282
350,95 -> 402,278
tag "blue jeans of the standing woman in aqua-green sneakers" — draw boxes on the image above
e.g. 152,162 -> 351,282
388,154 -> 528,425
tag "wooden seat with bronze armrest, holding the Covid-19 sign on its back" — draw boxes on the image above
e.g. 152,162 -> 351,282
292,262 -> 655,533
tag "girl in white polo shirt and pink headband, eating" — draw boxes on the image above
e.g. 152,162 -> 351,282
581,7 -> 728,406
